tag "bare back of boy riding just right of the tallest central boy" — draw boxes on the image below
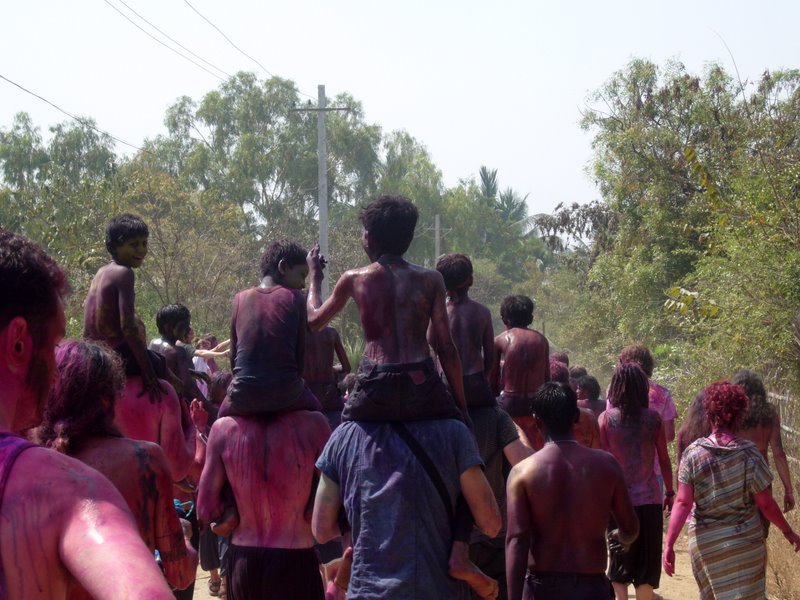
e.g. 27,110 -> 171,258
446,296 -> 494,376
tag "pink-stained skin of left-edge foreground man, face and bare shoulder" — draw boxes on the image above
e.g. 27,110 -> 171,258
0,307 -> 173,600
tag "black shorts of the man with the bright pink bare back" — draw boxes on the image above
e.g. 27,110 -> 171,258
226,544 -> 325,600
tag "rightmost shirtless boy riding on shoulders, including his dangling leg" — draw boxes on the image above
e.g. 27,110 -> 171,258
494,296 -> 550,450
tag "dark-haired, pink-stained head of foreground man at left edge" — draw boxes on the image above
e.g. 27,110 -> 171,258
0,228 -> 70,431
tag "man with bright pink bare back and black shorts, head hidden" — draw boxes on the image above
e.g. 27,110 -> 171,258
197,410 -> 330,600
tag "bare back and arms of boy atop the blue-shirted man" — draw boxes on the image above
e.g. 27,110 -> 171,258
308,236 -> 469,423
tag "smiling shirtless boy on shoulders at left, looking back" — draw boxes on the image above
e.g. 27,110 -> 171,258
83,213 -> 162,402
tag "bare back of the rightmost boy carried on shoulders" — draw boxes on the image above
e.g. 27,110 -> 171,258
495,327 -> 550,396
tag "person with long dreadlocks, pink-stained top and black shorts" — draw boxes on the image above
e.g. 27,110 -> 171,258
599,362 -> 675,600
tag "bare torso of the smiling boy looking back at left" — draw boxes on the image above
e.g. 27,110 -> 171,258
83,262 -> 134,348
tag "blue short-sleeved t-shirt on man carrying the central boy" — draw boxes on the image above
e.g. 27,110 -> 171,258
317,419 -> 482,600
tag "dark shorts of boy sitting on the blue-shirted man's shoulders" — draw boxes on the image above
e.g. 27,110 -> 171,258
342,358 -> 464,421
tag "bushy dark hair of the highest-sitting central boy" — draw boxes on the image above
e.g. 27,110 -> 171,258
359,195 -> 419,254
